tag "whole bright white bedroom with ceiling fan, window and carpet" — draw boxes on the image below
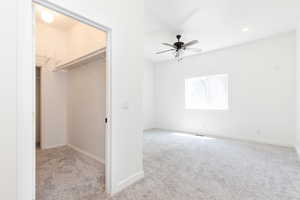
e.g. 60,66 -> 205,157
139,0 -> 300,200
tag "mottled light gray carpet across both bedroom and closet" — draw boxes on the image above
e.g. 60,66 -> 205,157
37,130 -> 300,200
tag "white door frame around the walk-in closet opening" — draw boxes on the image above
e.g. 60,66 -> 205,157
16,0 -> 112,200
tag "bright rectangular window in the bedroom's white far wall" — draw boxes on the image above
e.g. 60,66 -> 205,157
185,74 -> 228,110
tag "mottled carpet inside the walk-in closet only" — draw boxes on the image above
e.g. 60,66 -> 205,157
37,146 -> 105,200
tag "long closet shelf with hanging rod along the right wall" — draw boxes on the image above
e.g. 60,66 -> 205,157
53,47 -> 106,72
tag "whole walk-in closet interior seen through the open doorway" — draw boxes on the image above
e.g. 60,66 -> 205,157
35,5 -> 106,200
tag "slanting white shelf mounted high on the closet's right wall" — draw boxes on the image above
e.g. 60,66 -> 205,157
53,48 -> 106,72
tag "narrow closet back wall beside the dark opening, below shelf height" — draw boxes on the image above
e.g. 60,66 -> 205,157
41,67 -> 67,149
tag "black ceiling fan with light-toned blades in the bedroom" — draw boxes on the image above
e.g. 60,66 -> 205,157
156,35 -> 202,61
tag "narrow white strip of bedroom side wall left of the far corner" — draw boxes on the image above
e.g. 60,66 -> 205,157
143,60 -> 155,130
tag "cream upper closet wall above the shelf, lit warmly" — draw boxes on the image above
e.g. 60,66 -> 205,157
36,15 -> 106,69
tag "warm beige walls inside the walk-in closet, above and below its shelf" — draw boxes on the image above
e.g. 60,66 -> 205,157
36,9 -> 106,161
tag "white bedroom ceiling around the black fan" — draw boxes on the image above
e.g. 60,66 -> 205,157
145,0 -> 300,62
